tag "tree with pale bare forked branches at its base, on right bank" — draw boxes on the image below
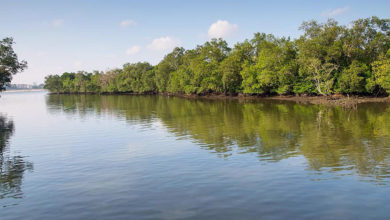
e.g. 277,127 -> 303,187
297,19 -> 343,95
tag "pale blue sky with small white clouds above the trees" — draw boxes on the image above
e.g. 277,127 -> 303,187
0,0 -> 390,84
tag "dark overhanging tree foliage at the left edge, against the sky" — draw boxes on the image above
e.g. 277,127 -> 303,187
0,37 -> 27,92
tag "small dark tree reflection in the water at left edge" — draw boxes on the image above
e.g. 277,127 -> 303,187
0,115 -> 33,206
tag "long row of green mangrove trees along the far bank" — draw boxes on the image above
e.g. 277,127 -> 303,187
45,17 -> 390,95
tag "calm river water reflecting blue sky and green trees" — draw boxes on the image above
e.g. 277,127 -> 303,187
0,92 -> 390,219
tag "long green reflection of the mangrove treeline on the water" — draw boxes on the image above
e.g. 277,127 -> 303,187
46,95 -> 390,181
